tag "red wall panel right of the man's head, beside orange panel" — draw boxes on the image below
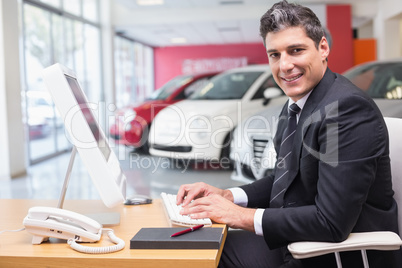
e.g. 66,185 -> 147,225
327,5 -> 354,73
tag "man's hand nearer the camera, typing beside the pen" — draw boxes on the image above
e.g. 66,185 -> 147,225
180,194 -> 255,232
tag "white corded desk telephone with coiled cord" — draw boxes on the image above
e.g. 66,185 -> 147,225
23,207 -> 125,253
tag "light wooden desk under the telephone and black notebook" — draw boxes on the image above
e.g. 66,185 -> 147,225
0,199 -> 227,268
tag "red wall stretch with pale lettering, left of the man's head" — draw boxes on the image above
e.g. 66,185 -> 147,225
154,43 -> 268,88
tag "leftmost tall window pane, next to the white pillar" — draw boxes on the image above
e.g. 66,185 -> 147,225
24,5 -> 56,159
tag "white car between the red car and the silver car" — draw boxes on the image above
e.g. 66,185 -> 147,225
149,64 -> 287,164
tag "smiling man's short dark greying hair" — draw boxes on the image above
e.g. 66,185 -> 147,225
260,0 -> 325,48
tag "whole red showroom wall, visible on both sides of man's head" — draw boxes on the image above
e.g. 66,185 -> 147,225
154,5 -> 354,88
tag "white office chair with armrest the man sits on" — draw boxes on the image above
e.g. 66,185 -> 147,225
288,117 -> 402,268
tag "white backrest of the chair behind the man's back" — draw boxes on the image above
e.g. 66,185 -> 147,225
384,117 -> 402,233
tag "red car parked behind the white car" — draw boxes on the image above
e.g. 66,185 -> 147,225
109,72 -> 217,153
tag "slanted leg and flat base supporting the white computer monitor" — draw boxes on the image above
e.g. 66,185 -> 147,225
57,146 -> 120,227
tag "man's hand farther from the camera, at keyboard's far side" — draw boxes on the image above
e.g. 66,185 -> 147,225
176,182 -> 233,207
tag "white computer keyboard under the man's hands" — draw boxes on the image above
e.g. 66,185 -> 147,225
161,193 -> 212,227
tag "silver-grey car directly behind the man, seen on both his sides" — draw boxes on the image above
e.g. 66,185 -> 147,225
230,59 -> 402,183
